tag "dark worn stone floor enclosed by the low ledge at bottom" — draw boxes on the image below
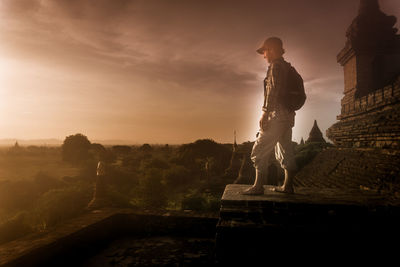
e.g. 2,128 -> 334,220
81,236 -> 215,267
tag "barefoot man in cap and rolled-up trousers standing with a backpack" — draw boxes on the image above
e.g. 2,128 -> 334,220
243,37 -> 305,195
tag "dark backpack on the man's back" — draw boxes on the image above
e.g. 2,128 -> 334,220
279,63 -> 306,111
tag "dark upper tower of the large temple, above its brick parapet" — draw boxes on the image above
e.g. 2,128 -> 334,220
337,0 -> 400,102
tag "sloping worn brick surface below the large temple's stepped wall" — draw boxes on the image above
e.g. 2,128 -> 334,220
295,148 -> 400,195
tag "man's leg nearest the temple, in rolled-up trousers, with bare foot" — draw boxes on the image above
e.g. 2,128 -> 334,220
275,128 -> 297,193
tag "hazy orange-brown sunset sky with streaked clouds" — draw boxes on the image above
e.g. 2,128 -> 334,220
0,0 -> 400,144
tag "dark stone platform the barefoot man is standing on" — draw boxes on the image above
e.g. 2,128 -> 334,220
216,184 -> 400,262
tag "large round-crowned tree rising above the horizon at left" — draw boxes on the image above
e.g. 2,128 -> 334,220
61,133 -> 91,165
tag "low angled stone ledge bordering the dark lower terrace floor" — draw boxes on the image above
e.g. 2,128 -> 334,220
0,209 -> 217,266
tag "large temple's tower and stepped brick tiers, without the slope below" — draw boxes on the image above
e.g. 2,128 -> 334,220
326,0 -> 400,149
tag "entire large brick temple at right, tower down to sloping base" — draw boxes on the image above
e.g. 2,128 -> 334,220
296,0 -> 400,195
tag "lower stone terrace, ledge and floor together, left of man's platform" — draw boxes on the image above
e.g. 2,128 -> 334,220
0,208 -> 218,267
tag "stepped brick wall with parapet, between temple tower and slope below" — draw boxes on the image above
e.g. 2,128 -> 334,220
326,76 -> 400,149
